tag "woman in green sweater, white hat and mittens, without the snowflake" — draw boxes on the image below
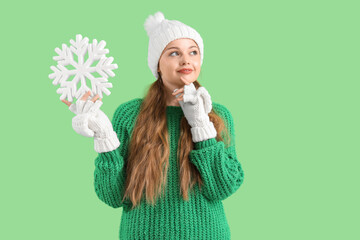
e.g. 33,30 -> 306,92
63,12 -> 244,240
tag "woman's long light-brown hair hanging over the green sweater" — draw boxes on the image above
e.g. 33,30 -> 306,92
122,76 -> 229,208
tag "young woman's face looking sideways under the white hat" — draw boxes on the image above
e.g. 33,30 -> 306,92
158,38 -> 201,87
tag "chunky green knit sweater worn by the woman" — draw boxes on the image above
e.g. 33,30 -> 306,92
94,98 -> 244,240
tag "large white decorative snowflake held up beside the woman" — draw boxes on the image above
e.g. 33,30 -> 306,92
49,34 -> 118,102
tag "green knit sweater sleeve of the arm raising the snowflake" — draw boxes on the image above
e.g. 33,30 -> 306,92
94,105 -> 131,208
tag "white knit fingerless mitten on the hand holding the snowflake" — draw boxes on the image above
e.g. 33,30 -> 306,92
69,96 -> 120,153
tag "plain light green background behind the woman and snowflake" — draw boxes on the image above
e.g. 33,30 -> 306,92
0,0 -> 360,240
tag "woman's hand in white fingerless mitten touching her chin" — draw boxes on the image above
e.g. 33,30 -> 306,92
172,77 -> 217,142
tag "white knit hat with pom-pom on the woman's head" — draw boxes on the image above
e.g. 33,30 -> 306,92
144,12 -> 204,79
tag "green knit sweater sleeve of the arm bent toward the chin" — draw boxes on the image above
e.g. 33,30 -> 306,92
189,104 -> 244,201
